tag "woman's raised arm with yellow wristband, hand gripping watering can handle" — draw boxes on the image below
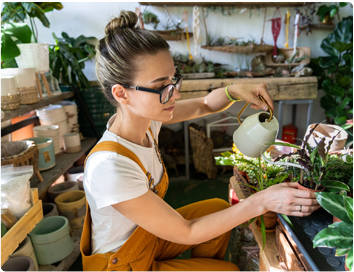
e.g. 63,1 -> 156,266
164,83 -> 274,124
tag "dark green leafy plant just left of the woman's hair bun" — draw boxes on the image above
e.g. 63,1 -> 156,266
49,32 -> 96,88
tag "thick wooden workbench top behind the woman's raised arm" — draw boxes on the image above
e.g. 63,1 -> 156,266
180,77 -> 318,101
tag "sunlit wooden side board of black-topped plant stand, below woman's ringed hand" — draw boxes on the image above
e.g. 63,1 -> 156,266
275,226 -> 306,272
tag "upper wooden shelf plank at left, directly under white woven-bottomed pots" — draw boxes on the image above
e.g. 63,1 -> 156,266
0,92 -> 74,122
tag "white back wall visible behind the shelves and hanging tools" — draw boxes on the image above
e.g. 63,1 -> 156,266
25,0 -> 354,138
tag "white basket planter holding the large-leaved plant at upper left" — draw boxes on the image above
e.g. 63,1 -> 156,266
15,43 -> 49,74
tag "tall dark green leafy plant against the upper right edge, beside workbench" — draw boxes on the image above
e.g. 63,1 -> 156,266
310,16 -> 354,146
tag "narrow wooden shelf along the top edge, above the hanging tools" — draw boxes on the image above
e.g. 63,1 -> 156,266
138,0 -> 312,7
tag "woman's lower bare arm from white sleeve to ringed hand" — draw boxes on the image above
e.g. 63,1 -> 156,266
112,183 -> 319,245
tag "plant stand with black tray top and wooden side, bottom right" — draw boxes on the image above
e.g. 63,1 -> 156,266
277,208 -> 345,272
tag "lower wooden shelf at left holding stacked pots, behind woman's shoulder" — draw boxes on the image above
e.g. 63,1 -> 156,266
30,138 -> 97,198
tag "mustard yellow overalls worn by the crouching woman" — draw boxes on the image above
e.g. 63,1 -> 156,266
80,130 -> 240,272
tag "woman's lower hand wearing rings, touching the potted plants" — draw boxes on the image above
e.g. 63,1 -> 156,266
250,182 -> 320,217
